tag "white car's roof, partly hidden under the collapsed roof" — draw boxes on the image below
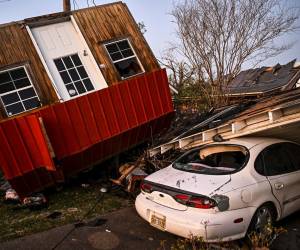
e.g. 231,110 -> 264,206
214,137 -> 288,149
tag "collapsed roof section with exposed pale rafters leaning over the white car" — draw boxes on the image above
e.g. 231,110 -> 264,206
148,89 -> 300,157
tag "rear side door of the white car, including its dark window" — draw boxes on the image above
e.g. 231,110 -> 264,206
263,142 -> 300,217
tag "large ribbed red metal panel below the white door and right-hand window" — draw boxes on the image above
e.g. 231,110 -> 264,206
40,70 -> 173,159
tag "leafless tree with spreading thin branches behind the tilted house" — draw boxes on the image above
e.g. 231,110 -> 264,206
162,0 -> 298,106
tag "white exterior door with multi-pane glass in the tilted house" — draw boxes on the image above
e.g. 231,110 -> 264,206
31,21 -> 107,100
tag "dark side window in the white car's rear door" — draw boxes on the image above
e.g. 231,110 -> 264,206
256,143 -> 295,176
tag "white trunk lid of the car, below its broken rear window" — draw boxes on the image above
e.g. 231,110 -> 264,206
146,166 -> 231,196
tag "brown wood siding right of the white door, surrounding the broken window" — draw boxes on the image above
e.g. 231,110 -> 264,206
73,2 -> 159,84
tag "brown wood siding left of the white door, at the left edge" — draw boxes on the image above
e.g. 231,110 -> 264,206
0,23 -> 58,117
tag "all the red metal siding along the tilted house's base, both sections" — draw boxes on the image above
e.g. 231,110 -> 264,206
0,70 -> 173,195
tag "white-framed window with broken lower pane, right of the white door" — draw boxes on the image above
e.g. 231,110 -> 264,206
104,39 -> 144,79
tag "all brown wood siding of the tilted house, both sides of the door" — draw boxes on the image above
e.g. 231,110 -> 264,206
0,2 -> 160,121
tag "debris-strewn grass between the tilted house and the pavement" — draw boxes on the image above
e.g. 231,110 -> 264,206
0,185 -> 131,241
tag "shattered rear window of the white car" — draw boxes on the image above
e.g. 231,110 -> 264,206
172,144 -> 248,175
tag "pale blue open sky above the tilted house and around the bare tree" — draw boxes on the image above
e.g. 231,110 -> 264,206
0,0 -> 300,67
